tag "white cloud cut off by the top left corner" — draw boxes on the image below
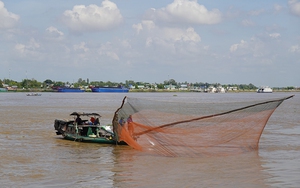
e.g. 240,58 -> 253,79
0,1 -> 20,29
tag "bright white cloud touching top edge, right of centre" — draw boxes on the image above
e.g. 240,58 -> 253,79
148,0 -> 222,24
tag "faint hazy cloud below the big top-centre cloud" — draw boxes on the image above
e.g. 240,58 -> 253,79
133,20 -> 201,57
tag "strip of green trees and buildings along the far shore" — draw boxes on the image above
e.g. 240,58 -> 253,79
0,78 -> 297,90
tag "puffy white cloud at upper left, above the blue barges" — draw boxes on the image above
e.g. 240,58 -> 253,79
62,0 -> 123,33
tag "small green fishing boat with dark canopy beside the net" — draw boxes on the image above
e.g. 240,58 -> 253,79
54,112 -> 125,145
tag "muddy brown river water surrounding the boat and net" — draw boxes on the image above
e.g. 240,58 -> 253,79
0,93 -> 300,188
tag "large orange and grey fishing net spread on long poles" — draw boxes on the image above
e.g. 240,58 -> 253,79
113,96 -> 293,156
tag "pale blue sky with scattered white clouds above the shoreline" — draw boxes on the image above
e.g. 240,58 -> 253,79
0,0 -> 300,87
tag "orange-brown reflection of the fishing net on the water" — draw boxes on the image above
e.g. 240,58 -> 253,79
115,152 -> 267,187
